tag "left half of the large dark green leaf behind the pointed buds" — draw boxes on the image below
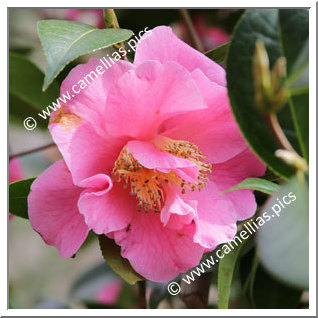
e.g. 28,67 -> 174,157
227,9 -> 293,178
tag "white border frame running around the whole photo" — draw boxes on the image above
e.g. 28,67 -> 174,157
0,0 -> 317,317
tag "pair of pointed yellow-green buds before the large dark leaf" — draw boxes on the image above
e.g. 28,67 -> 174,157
253,40 -> 287,113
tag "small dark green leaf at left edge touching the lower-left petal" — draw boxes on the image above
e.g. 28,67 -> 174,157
9,178 -> 35,219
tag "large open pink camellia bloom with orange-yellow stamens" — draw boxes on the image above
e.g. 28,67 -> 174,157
28,27 -> 265,282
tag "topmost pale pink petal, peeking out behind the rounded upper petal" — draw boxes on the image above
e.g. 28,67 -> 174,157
134,26 -> 226,86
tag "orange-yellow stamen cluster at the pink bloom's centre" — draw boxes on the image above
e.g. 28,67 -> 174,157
112,138 -> 212,213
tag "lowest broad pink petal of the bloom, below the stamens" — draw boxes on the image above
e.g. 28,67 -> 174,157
114,212 -> 204,282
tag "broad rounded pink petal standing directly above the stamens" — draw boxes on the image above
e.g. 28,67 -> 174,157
106,61 -> 206,140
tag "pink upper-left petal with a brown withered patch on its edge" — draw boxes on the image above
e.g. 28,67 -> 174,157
49,59 -> 133,183
